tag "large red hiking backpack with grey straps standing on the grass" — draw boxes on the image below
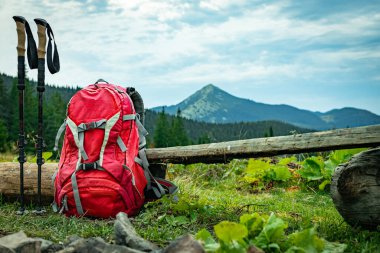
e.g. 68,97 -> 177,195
54,80 -> 176,218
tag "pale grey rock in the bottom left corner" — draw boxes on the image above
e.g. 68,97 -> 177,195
0,231 -> 41,253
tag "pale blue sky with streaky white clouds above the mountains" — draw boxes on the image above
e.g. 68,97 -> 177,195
0,0 -> 380,115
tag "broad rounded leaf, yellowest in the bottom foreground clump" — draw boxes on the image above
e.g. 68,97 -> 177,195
214,221 -> 248,244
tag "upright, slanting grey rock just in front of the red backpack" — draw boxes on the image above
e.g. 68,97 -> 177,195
114,213 -> 158,252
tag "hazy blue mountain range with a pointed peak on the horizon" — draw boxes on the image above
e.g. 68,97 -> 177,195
152,84 -> 380,130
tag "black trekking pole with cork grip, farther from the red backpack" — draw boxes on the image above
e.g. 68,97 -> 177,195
13,16 -> 37,214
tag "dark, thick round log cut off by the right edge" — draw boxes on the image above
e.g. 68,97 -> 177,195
331,148 -> 380,230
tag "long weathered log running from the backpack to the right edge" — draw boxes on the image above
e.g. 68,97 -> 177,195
147,125 -> 380,164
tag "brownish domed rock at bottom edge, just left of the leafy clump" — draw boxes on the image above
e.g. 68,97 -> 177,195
163,235 -> 205,253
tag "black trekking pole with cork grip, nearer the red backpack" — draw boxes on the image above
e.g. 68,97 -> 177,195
34,18 -> 59,214
